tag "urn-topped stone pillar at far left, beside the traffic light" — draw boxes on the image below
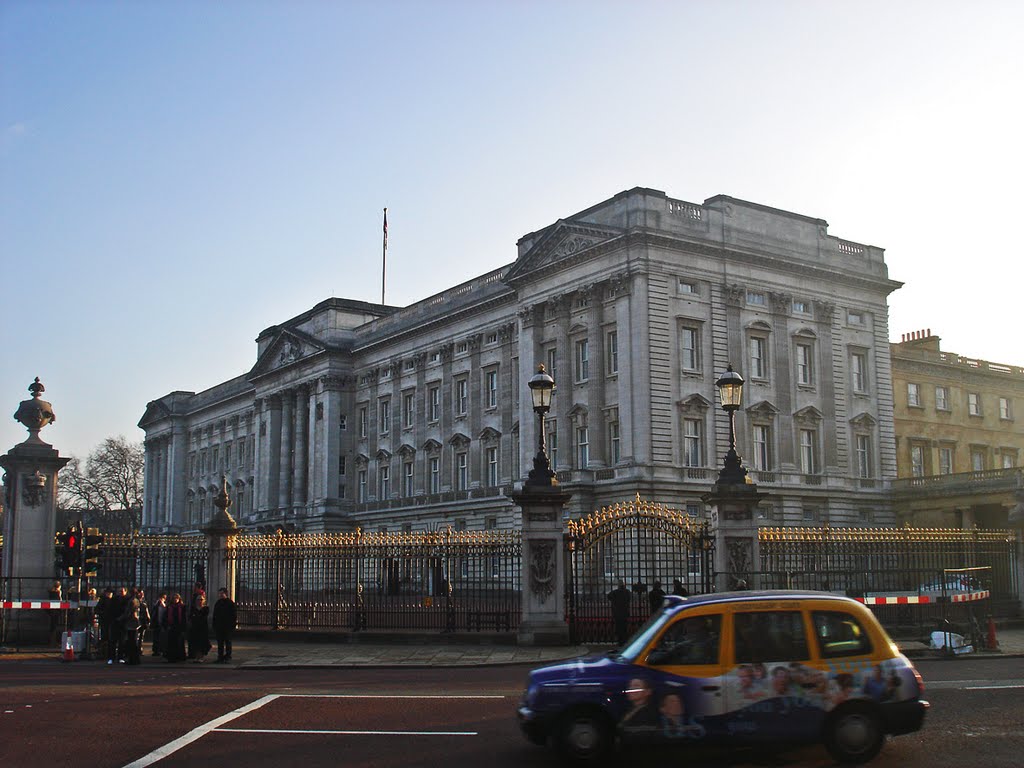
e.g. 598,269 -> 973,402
0,377 -> 70,642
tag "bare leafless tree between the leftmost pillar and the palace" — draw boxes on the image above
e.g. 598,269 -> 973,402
58,435 -> 145,534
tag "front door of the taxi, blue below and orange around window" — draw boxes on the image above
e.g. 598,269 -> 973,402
620,606 -> 725,743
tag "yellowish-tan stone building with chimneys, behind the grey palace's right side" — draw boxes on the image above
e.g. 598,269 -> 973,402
891,330 -> 1024,528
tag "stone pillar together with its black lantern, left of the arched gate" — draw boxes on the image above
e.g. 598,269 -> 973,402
511,366 -> 572,645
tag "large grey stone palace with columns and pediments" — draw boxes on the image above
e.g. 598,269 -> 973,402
139,188 -> 900,530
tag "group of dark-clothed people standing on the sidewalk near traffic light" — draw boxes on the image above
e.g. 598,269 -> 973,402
95,583 -> 238,665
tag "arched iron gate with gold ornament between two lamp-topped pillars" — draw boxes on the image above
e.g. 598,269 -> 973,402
565,495 -> 715,643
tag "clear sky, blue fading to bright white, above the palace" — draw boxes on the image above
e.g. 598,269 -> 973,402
0,0 -> 1024,457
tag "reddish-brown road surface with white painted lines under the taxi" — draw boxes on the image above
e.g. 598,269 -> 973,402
0,657 -> 1024,768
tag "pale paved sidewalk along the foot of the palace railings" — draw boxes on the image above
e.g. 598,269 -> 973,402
6,627 -> 1024,670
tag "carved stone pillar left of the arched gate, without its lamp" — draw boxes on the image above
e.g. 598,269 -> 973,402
511,483 -> 572,645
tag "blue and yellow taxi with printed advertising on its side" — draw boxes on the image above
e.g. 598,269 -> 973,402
518,590 -> 929,763
